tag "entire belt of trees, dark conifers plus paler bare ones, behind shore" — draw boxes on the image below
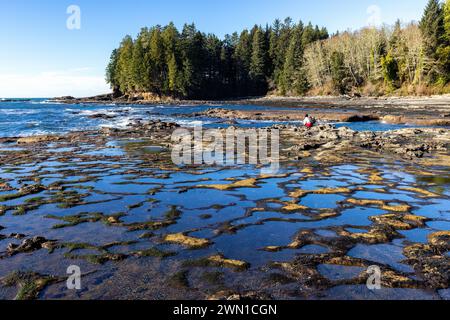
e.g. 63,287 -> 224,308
106,0 -> 450,99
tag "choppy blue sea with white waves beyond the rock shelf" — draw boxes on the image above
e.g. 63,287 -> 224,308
0,99 -> 440,137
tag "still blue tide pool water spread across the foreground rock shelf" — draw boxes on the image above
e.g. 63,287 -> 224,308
0,135 -> 450,299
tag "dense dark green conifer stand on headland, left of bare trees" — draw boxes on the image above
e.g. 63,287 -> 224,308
106,18 -> 328,99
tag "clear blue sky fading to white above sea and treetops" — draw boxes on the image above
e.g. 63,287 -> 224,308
0,0 -> 428,98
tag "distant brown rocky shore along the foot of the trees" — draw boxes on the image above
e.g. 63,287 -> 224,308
52,94 -> 450,127
